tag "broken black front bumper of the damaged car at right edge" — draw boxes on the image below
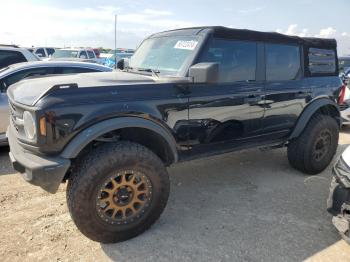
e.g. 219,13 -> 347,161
327,168 -> 350,244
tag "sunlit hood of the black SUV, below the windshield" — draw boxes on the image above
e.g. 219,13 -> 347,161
7,71 -> 156,106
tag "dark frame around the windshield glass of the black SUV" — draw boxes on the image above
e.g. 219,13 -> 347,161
128,34 -> 205,77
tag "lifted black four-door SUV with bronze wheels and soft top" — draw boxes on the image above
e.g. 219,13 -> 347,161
7,27 -> 342,243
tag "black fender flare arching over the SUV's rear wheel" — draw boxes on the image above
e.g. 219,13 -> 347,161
288,97 -> 341,140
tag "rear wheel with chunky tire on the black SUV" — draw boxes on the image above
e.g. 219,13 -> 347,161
288,115 -> 339,174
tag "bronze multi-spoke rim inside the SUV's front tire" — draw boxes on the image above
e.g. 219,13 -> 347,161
96,170 -> 152,224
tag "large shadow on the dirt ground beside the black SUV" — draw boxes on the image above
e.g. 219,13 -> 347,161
101,145 -> 347,261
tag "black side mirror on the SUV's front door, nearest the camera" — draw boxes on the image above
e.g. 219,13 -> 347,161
189,63 -> 219,83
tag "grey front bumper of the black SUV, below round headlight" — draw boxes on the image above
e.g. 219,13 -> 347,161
7,127 -> 71,193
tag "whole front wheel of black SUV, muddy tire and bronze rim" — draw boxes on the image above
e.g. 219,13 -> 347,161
67,142 -> 169,243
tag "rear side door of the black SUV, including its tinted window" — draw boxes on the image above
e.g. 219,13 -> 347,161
262,43 -> 311,139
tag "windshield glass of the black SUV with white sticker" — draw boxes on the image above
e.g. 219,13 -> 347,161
129,36 -> 199,76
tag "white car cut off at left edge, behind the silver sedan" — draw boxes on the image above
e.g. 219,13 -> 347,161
0,45 -> 40,68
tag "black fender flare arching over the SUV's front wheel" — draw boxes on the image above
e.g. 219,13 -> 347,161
61,117 -> 178,163
